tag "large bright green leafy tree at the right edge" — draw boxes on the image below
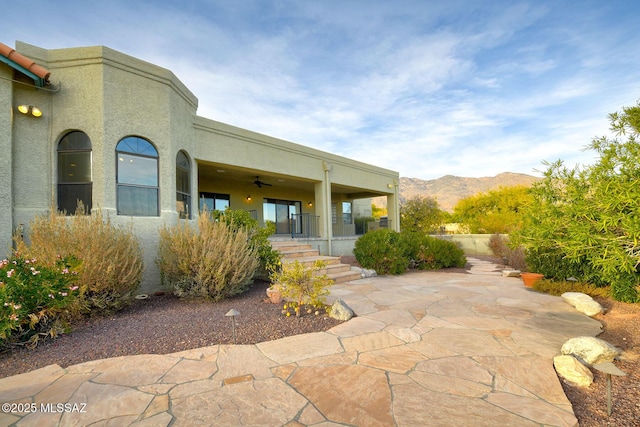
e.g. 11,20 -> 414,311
514,102 -> 640,302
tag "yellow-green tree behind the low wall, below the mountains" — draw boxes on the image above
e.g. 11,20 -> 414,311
453,185 -> 530,234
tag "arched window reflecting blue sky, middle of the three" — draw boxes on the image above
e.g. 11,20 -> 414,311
116,136 -> 160,216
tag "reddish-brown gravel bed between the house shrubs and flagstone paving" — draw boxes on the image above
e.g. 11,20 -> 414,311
0,282 -> 342,378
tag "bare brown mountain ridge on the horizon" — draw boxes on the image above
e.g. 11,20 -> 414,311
373,172 -> 540,212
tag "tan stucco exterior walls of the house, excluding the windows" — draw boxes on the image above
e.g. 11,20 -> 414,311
0,42 -> 398,291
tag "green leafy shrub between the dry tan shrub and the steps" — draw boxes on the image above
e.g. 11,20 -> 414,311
211,209 -> 282,280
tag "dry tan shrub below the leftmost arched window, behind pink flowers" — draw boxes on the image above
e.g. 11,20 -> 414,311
15,207 -> 144,311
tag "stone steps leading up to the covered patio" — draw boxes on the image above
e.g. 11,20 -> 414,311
271,240 -> 360,283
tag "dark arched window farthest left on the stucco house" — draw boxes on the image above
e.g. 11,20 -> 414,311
58,131 -> 92,215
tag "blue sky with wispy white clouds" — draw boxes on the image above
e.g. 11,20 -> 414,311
0,0 -> 640,179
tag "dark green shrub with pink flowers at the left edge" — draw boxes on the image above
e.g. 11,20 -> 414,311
0,256 -> 80,347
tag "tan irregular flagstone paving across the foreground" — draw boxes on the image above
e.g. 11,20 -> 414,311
0,258 -> 602,427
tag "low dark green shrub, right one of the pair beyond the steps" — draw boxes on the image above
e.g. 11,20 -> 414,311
400,231 -> 467,270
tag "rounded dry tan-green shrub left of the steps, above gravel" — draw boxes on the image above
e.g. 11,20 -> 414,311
156,212 -> 258,301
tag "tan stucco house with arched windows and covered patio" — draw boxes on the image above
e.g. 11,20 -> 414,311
0,42 -> 399,289
